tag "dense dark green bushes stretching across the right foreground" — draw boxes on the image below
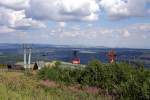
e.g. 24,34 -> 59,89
39,60 -> 150,100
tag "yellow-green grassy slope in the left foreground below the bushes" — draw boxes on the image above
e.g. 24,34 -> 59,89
0,72 -> 109,100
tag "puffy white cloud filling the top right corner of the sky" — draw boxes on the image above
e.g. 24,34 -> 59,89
100,0 -> 150,19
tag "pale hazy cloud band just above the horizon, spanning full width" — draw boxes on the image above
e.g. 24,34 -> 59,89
0,23 -> 150,48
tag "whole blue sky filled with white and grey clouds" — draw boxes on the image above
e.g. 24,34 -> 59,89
0,0 -> 150,48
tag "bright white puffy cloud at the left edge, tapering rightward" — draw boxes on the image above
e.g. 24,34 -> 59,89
0,7 -> 46,29
